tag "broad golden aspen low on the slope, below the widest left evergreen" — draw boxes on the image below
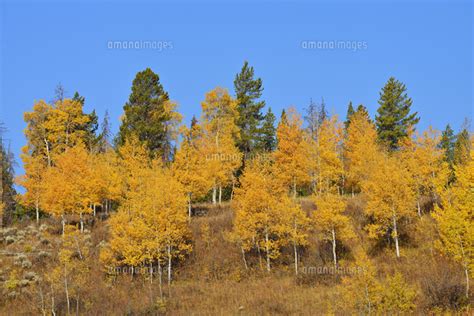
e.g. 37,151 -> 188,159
110,160 -> 192,296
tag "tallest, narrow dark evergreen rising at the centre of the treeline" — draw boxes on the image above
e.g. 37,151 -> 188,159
234,61 -> 265,155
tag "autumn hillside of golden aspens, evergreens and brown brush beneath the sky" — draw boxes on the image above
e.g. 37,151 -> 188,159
0,62 -> 474,315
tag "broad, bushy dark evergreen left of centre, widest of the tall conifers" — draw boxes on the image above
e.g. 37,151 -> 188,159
117,68 -> 170,159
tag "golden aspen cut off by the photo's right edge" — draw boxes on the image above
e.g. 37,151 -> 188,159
433,139 -> 474,297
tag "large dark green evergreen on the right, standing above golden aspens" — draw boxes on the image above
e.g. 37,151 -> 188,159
375,77 -> 420,151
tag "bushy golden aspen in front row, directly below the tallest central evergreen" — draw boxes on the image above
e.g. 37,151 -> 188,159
231,159 -> 288,271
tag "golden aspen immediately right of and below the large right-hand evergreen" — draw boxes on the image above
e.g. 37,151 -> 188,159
399,127 -> 448,216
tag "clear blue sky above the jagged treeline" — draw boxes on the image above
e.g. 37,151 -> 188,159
0,0 -> 473,178
